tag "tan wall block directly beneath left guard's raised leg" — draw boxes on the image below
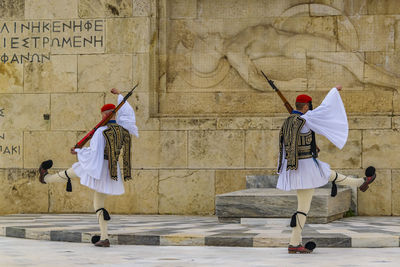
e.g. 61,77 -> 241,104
48,175 -> 94,214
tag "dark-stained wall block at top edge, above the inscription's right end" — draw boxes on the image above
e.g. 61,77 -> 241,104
78,0 -> 132,18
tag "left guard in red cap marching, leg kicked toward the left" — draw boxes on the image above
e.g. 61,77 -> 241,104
39,86 -> 139,247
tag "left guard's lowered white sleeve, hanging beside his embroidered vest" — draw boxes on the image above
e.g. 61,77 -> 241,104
72,126 -> 107,179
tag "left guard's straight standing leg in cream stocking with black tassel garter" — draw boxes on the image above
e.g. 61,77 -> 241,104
93,191 -> 110,247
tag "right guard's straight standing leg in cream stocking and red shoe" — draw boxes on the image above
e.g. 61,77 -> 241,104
289,189 -> 314,253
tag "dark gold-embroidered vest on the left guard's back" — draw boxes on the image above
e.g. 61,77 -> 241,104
103,123 -> 132,181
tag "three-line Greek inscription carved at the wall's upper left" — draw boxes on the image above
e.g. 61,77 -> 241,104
0,19 -> 105,64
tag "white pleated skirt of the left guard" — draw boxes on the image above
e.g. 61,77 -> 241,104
72,160 -> 125,195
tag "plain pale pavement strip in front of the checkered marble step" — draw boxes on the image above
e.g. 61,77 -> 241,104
0,237 -> 400,267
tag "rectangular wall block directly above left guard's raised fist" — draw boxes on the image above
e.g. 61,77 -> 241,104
78,55 -> 133,95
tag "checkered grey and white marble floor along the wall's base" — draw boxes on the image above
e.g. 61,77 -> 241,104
0,214 -> 400,247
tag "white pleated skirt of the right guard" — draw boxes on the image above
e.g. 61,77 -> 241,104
276,158 -> 331,191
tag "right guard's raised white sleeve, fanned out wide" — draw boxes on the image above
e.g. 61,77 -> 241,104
301,88 -> 349,149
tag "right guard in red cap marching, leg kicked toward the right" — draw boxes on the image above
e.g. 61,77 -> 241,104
262,72 -> 376,254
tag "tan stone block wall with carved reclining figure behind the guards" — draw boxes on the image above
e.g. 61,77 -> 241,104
0,0 -> 400,215
